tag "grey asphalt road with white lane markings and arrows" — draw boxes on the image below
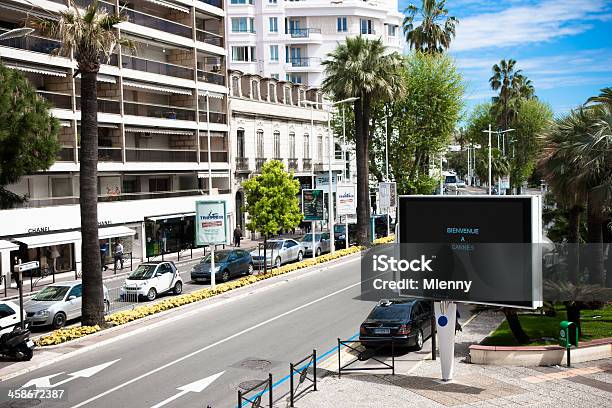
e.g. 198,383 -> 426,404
0,257 -> 382,408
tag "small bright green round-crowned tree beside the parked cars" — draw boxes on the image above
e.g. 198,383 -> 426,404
242,160 -> 302,268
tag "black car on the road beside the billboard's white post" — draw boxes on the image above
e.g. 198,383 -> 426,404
359,299 -> 433,350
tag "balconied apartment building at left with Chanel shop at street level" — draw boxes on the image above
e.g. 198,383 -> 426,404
0,0 -> 234,277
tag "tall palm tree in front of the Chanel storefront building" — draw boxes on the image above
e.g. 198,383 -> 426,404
34,0 -> 133,326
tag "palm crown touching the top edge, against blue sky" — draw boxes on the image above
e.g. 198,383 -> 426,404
402,0 -> 459,53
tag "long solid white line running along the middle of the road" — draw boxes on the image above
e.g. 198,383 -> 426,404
72,282 -> 361,408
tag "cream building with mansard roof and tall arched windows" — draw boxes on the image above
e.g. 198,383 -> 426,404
228,70 -> 347,236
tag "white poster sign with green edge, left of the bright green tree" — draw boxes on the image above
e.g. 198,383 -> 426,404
196,200 -> 227,245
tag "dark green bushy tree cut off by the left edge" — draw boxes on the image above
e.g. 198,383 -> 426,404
0,64 -> 60,209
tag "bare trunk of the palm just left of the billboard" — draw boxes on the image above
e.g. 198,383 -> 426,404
354,98 -> 370,245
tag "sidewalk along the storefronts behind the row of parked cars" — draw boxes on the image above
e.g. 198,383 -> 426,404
0,234 -> 300,300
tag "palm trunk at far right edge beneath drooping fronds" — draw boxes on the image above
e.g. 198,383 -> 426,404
587,192 -> 604,285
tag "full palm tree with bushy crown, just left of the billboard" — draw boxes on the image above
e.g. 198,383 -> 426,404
323,36 -> 404,245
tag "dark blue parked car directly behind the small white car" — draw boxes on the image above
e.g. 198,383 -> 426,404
191,249 -> 253,282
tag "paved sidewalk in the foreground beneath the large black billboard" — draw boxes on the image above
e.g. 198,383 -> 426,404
295,313 -> 612,408
